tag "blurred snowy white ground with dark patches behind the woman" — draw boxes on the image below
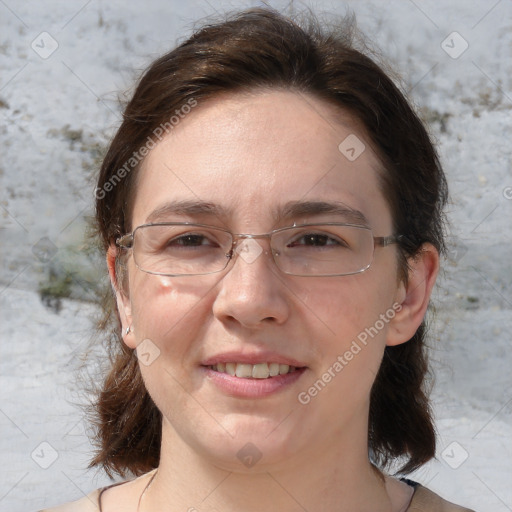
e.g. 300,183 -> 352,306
0,0 -> 512,512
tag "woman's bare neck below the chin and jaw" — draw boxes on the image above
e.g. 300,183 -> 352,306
140,420 -> 394,512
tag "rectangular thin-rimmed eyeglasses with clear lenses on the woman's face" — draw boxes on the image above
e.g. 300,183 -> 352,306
116,222 -> 399,277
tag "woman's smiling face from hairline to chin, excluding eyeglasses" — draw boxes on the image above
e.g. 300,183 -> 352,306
121,91 -> 404,470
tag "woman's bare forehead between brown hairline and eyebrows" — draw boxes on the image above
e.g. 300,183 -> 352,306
133,91 -> 391,230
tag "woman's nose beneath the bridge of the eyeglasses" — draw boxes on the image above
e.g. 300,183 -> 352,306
213,239 -> 290,329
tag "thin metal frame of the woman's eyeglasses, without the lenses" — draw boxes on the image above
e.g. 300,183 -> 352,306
116,222 -> 402,277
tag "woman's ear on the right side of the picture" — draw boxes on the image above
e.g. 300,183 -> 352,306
386,244 -> 439,346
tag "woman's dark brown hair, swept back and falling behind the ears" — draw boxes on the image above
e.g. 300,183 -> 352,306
91,9 -> 447,476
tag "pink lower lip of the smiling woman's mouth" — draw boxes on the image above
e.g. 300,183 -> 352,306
202,366 -> 307,398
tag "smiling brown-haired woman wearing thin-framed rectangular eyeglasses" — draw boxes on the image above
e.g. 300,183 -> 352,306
42,5 -> 474,512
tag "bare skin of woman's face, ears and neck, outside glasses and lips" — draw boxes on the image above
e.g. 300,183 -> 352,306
103,91 -> 438,512
